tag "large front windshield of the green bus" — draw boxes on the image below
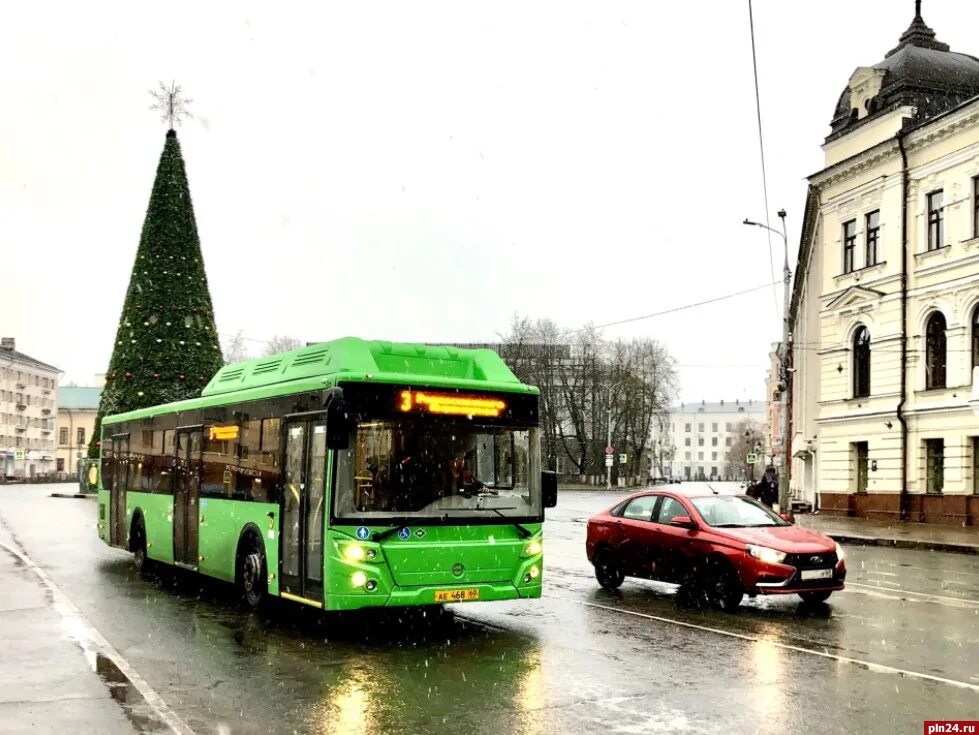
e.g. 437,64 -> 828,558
334,420 -> 541,521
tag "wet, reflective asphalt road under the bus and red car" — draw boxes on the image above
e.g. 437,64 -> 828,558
0,486 -> 979,735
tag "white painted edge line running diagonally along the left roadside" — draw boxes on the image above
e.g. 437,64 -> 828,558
0,541 -> 196,735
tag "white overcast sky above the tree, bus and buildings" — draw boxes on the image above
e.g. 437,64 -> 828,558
0,0 -> 979,401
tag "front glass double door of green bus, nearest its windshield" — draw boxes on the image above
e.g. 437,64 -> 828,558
279,414 -> 326,603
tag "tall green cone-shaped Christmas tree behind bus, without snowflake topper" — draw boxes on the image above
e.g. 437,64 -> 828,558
88,128 -> 223,457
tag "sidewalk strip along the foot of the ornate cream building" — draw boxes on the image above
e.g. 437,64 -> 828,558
795,514 -> 979,554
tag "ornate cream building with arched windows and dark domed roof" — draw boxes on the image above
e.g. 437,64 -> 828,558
790,5 -> 979,525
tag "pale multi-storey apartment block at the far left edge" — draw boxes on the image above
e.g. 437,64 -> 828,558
0,337 -> 59,481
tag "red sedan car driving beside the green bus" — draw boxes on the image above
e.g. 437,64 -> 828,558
585,489 -> 846,610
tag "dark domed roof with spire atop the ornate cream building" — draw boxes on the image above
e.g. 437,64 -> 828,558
826,2 -> 979,142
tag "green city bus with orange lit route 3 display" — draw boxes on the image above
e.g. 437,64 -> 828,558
98,337 -> 557,610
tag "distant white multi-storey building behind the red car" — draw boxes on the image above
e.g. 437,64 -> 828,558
652,400 -> 768,480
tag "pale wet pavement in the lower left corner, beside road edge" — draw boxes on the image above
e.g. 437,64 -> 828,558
0,528 -> 135,735
